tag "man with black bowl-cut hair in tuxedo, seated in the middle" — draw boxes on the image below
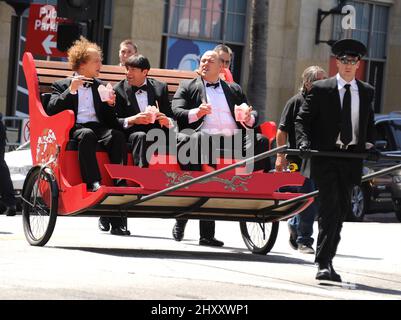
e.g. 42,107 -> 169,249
114,55 -> 174,168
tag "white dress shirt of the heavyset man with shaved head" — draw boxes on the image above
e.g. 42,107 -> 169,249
188,81 -> 255,136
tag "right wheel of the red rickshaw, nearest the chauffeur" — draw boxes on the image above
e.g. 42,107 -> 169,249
239,221 -> 279,254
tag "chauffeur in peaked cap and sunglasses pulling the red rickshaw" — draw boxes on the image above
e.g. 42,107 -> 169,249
295,39 -> 378,282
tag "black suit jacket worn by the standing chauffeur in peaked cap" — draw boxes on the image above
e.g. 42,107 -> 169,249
295,77 -> 374,184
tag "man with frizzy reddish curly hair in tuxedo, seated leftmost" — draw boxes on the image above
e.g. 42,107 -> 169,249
47,37 -> 127,235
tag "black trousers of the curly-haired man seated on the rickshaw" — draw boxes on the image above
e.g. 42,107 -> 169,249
70,122 -> 127,184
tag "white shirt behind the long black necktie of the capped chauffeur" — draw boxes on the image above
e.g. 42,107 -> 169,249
336,73 -> 359,145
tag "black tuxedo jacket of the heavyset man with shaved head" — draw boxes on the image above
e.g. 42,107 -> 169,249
172,77 -> 258,130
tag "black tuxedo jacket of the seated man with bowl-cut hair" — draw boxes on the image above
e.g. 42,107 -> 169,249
114,78 -> 173,135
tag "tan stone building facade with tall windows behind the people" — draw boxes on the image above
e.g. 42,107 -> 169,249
0,0 -> 401,121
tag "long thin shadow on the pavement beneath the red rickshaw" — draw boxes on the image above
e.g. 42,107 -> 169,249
53,246 -> 313,265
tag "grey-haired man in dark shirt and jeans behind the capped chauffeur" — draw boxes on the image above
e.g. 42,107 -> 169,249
275,66 -> 327,254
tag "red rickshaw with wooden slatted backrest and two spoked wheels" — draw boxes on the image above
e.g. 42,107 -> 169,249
22,53 -> 313,253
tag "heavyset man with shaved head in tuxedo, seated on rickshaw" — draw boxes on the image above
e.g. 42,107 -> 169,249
172,51 -> 270,246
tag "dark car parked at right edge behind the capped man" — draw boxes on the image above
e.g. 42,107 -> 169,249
348,112 -> 401,222
